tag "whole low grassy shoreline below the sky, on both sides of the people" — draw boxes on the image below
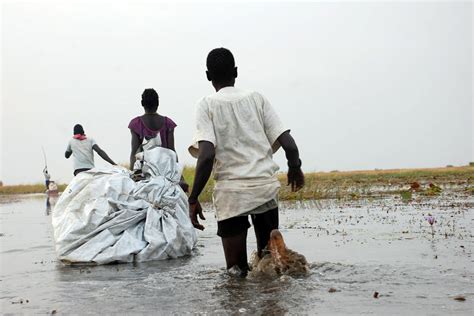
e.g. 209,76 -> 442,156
0,166 -> 474,202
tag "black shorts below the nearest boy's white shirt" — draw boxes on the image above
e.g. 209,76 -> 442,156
217,207 -> 278,238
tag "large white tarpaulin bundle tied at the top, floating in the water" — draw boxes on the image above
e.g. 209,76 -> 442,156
52,147 -> 197,264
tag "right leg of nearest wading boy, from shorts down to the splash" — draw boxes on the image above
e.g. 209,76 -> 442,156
251,208 -> 278,258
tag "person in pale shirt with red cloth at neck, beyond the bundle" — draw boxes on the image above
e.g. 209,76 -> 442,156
65,124 -> 116,176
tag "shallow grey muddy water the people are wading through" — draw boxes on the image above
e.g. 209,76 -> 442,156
0,195 -> 474,315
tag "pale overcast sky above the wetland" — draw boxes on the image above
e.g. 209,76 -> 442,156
0,0 -> 474,184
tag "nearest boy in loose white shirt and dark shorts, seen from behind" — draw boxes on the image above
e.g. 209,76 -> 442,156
188,48 -> 304,276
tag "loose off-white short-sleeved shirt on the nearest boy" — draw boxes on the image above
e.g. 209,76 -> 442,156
189,87 -> 288,221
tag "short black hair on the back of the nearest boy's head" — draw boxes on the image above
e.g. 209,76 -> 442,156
206,47 -> 235,81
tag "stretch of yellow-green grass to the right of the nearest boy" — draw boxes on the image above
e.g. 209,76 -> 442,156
279,167 -> 474,201
